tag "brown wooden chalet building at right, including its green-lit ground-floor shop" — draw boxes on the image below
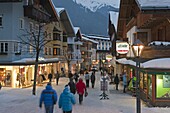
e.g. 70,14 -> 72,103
117,0 -> 170,106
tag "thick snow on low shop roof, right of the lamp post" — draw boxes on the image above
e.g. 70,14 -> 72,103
141,58 -> 170,69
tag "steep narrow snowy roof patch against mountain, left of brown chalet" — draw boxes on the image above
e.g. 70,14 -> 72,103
109,11 -> 119,31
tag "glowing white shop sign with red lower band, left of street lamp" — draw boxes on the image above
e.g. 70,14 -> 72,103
116,42 -> 129,54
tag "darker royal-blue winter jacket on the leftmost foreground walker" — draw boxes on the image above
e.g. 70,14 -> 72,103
39,84 -> 57,106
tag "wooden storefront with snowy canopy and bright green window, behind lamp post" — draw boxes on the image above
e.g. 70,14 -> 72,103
117,58 -> 170,106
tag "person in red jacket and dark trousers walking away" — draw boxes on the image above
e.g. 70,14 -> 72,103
76,78 -> 87,104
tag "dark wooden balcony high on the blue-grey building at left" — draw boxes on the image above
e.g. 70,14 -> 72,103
24,5 -> 51,22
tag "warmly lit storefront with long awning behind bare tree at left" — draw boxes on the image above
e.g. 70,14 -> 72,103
0,59 -> 59,88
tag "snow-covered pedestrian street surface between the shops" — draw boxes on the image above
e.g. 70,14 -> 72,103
0,72 -> 170,113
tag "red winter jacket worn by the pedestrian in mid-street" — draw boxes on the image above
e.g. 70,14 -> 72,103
76,79 -> 86,94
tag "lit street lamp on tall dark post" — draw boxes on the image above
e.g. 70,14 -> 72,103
132,39 -> 144,113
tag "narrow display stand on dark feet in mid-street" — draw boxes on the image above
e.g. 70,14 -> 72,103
100,77 -> 109,100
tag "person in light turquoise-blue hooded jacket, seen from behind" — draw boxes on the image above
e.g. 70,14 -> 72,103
58,85 -> 76,113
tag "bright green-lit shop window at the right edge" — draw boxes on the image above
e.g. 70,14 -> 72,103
156,75 -> 170,98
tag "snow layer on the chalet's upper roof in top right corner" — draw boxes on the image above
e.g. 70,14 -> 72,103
137,0 -> 170,9
